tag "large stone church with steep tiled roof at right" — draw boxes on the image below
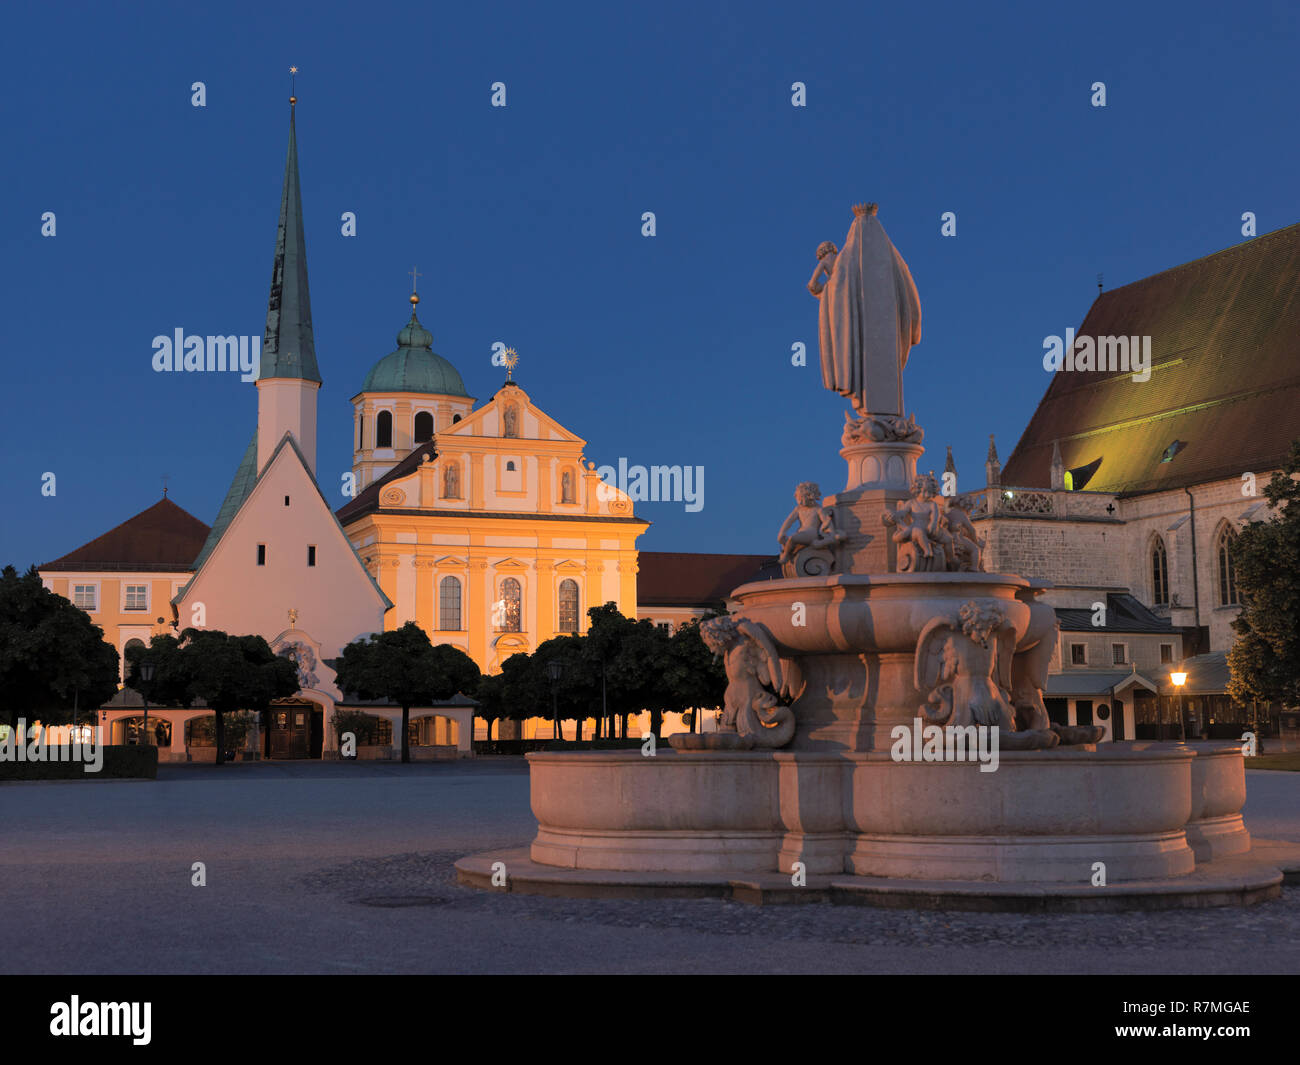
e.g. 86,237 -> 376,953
974,225 -> 1300,739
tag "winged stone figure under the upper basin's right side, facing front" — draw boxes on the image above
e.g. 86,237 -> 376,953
914,599 -> 1061,750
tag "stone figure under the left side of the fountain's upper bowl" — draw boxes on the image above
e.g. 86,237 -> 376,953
699,615 -> 794,748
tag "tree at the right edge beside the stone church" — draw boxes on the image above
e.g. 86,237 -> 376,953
1227,441 -> 1300,706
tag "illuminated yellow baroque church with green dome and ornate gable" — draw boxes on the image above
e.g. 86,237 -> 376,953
338,296 -> 649,736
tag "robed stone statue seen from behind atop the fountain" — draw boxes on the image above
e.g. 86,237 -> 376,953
809,203 -> 920,417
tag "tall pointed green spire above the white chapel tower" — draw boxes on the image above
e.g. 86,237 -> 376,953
259,100 -> 321,384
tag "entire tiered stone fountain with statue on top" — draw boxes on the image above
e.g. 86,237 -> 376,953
458,204 -> 1300,910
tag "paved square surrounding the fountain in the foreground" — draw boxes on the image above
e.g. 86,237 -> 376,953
0,759 -> 1300,973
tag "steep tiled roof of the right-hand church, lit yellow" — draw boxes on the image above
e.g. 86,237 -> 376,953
1002,225 -> 1300,494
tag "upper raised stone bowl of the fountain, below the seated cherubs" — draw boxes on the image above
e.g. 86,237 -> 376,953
732,573 -> 1031,654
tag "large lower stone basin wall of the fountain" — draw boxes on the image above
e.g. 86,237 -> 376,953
528,744 -> 1206,884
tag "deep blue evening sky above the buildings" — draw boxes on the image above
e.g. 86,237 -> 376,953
0,1 -> 1300,567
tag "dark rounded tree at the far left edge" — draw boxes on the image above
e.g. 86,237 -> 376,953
0,566 -> 118,728
